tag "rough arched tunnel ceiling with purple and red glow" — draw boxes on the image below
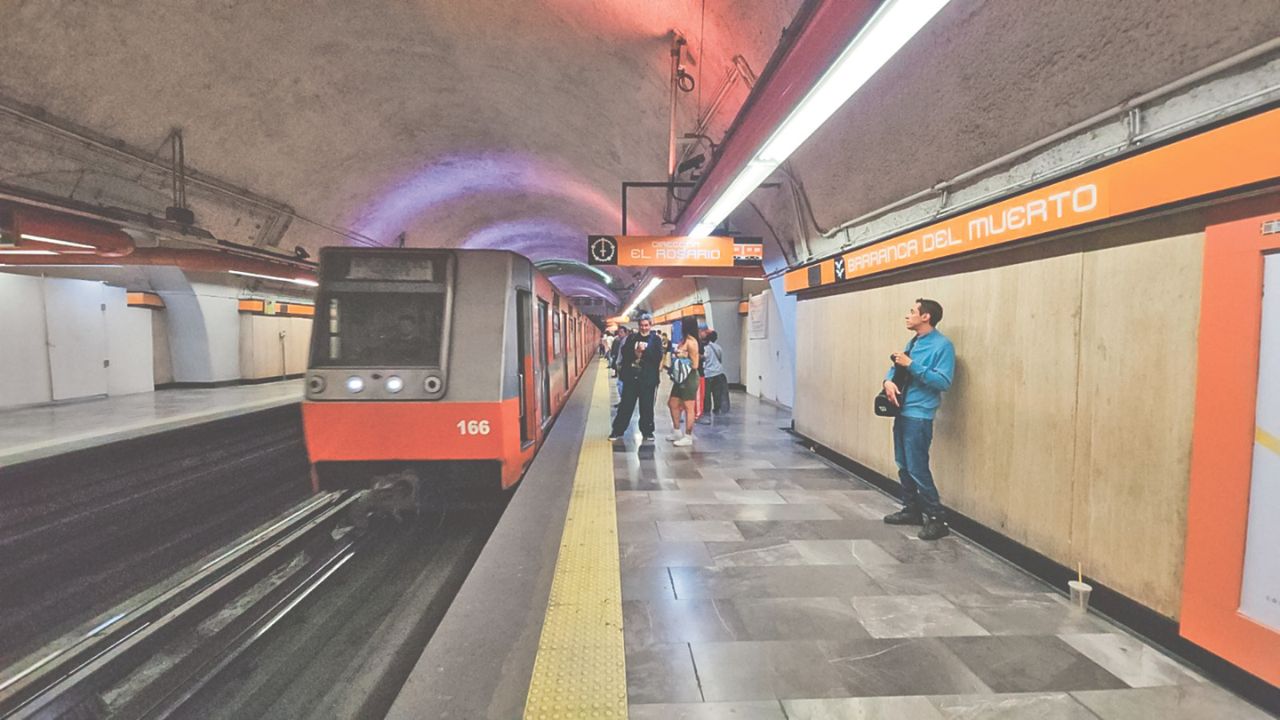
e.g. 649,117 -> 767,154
0,0 -> 1280,300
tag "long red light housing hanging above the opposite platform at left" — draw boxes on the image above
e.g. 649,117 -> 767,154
0,247 -> 316,286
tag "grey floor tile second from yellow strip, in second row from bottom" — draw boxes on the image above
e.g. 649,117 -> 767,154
692,642 -> 847,701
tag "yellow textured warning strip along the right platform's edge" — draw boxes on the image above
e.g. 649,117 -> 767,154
525,372 -> 627,720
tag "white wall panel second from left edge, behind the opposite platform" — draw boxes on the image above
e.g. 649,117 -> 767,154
44,278 -> 108,400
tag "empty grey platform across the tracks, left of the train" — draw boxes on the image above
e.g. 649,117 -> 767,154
0,379 -> 302,468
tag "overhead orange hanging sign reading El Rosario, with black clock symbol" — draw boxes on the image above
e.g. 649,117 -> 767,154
586,234 -> 764,268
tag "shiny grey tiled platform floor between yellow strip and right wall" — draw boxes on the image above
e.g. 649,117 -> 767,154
613,387 -> 1268,720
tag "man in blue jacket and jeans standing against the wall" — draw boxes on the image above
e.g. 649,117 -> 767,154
884,297 -> 956,541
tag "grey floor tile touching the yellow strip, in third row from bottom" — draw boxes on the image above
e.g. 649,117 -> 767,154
622,597 -> 751,648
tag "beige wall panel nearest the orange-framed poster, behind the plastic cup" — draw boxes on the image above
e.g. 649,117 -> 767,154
1071,233 -> 1203,616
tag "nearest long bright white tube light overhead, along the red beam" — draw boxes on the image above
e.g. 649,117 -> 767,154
689,0 -> 948,237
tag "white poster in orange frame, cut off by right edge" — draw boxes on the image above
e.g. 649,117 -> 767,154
1240,255 -> 1280,632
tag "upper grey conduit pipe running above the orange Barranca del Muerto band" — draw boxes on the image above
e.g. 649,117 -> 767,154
822,37 -> 1280,238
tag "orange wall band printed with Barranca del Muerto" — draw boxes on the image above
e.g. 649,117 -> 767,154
783,109 -> 1280,293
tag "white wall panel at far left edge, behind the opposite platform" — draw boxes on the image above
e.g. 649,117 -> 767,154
0,273 -> 54,407
